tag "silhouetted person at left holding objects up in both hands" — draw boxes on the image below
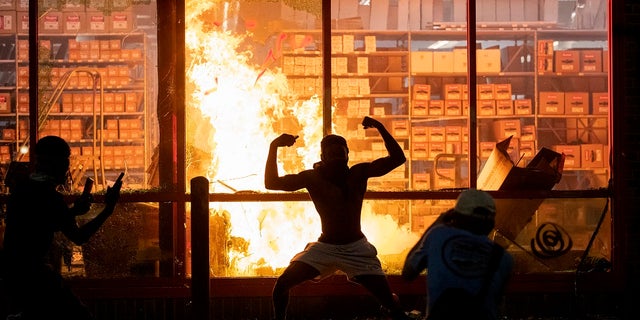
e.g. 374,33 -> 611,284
3,136 -> 122,320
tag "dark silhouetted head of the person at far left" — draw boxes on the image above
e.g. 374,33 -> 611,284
35,136 -> 71,184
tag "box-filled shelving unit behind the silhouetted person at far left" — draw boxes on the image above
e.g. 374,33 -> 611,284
0,28 -> 150,189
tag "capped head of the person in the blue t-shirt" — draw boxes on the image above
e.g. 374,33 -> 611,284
452,189 -> 496,234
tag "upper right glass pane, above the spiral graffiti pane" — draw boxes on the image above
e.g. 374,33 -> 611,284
476,1 -> 610,190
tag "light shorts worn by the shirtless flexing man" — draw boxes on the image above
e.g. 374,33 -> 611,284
291,237 -> 385,279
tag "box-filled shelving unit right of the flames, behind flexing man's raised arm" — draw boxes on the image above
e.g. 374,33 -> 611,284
283,28 -> 608,198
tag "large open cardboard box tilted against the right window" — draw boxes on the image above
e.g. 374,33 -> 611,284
477,139 -> 564,241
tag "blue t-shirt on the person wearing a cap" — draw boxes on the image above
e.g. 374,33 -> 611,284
405,224 -> 513,319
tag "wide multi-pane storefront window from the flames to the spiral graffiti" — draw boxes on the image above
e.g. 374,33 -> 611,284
178,1 -> 611,276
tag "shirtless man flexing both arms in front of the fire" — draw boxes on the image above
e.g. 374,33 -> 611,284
264,117 -> 408,319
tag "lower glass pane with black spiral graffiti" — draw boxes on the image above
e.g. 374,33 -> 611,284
493,199 -> 612,273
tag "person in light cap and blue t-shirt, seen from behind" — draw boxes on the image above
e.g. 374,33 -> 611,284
402,189 -> 513,320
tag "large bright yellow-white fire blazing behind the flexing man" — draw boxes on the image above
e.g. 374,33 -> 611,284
186,0 -> 417,276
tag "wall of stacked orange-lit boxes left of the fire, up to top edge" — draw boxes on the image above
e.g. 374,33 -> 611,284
0,0 -> 149,188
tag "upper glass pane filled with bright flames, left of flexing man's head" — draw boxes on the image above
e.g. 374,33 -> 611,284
185,1 -> 323,192
